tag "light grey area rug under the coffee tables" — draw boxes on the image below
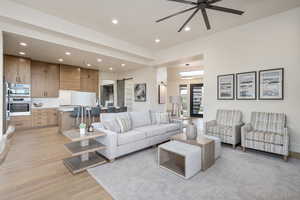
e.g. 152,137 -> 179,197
88,146 -> 300,200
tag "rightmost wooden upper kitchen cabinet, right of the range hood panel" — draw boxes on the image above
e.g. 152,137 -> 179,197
80,69 -> 99,93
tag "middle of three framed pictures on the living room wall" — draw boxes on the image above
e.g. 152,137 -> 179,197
236,71 -> 257,100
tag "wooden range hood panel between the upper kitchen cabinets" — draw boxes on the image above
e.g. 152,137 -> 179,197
59,65 -> 81,90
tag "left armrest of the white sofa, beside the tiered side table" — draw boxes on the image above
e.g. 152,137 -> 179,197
95,126 -> 118,160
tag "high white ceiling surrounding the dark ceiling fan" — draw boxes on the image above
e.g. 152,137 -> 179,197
11,0 -> 300,50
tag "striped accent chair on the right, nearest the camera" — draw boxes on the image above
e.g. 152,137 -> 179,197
242,112 -> 289,160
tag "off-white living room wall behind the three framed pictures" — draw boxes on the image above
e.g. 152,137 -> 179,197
159,8 -> 300,152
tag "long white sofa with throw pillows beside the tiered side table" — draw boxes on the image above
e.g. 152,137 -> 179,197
93,111 -> 183,161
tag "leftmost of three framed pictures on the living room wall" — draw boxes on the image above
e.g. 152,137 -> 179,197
217,74 -> 235,100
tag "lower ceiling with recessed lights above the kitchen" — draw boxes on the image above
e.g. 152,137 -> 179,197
4,32 -> 145,72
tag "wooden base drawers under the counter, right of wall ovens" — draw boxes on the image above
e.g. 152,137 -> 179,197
32,108 -> 58,128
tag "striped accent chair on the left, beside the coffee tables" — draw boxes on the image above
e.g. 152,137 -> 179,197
205,110 -> 244,148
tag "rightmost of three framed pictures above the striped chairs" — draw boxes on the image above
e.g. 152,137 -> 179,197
259,68 -> 284,100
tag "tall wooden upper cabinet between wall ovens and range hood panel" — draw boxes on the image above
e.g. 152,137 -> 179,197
31,61 -> 59,98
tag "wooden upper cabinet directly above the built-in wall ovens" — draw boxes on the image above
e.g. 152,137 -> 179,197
4,55 -> 31,84
